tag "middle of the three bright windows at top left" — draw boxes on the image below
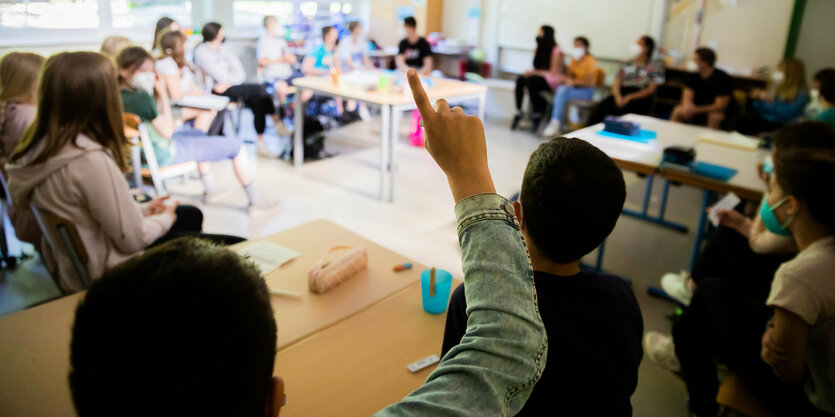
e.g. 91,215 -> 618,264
110,0 -> 191,29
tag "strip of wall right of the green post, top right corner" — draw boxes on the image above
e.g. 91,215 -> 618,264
795,0 -> 835,82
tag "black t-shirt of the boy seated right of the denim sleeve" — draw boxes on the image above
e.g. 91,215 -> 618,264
441,271 -> 644,416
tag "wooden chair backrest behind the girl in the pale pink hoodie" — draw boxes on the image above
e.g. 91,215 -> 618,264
30,204 -> 91,288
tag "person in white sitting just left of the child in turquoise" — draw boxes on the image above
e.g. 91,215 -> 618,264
262,16 -> 304,104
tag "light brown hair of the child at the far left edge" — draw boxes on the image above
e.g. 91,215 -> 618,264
0,52 -> 45,103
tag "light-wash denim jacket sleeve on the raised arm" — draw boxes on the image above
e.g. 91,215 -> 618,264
376,194 -> 548,417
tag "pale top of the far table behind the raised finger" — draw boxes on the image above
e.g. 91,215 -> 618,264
293,75 -> 487,106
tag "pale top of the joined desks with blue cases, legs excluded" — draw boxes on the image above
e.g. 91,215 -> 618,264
565,114 -> 768,200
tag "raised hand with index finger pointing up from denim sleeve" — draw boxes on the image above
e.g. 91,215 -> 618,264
406,69 -> 496,202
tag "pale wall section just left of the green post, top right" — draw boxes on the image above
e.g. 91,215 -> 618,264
699,0 -> 792,74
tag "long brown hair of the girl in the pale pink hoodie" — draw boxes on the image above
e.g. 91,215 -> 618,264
11,52 -> 127,171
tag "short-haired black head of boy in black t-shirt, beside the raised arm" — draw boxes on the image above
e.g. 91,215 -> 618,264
520,138 -> 626,264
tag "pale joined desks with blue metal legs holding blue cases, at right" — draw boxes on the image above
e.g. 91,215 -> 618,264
564,114 -> 768,269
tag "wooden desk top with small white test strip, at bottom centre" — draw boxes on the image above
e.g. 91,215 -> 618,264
275,282 -> 458,417
